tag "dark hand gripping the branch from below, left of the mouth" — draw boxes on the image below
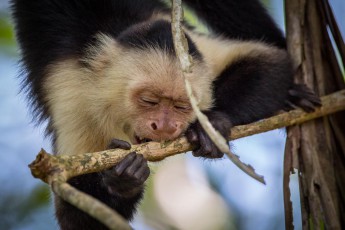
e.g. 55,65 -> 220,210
102,139 -> 150,198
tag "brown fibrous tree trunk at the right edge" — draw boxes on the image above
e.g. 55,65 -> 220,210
284,0 -> 345,229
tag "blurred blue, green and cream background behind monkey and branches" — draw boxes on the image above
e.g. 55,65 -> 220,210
0,0 -> 345,230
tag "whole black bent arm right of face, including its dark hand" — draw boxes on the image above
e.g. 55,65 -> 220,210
187,45 -> 320,158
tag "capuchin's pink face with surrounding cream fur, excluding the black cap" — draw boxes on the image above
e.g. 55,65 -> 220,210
87,42 -> 212,143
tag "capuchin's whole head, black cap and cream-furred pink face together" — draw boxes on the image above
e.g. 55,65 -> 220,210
88,23 -> 212,144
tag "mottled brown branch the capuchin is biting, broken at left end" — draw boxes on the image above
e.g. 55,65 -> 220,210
29,90 -> 345,181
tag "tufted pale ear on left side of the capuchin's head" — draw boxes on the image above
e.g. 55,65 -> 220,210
81,33 -> 122,73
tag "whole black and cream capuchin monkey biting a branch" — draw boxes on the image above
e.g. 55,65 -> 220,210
11,0 -> 320,229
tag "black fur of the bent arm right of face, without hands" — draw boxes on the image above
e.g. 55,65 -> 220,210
214,55 -> 292,125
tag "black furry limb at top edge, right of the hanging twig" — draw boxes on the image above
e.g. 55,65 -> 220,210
183,0 -> 286,48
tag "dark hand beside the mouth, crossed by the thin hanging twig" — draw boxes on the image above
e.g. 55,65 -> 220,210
186,111 -> 232,158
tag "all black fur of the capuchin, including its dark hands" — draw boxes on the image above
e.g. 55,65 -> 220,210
11,0 -> 318,229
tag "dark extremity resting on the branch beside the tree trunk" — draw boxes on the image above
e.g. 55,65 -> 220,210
285,84 -> 321,112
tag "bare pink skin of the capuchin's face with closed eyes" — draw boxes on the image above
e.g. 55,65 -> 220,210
132,89 -> 194,143
